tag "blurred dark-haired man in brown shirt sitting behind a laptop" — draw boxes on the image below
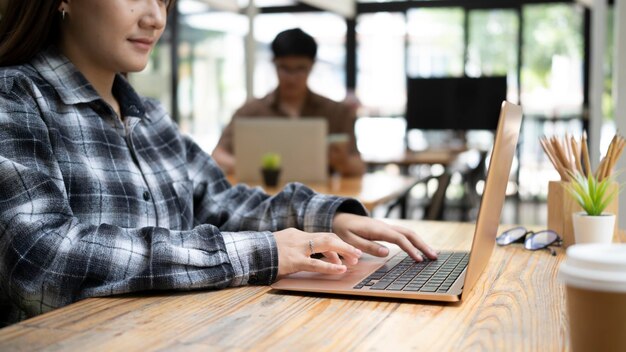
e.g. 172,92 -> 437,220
212,28 -> 365,176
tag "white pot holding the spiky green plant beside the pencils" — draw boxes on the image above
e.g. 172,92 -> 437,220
572,212 -> 615,243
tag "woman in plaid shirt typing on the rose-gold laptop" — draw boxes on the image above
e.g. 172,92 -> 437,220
0,0 -> 435,325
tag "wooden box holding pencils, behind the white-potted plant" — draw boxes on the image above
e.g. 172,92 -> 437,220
548,181 -> 619,248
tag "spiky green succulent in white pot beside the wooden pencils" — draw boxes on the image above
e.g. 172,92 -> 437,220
565,172 -> 618,243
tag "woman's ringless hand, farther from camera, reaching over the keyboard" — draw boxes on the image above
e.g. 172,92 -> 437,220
333,213 -> 437,261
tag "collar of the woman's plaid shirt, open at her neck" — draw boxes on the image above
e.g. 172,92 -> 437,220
32,47 -> 146,117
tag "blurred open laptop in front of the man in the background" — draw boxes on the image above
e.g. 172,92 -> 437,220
234,117 -> 328,183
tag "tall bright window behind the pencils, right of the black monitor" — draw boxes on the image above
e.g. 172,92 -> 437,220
519,4 -> 583,198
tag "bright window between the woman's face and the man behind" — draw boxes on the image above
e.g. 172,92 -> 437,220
178,11 -> 247,152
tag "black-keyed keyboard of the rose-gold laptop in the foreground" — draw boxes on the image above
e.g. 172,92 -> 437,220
354,252 -> 469,293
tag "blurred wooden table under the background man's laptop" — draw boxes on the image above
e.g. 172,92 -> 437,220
227,172 -> 419,211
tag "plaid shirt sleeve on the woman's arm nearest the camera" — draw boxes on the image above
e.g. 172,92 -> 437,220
0,78 -> 278,317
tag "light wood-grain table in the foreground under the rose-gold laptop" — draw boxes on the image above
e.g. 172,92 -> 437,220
0,220 -> 569,352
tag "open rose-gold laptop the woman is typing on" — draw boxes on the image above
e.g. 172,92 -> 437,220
272,101 -> 522,302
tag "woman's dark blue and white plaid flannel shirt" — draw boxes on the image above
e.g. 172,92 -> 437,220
0,49 -> 365,326
